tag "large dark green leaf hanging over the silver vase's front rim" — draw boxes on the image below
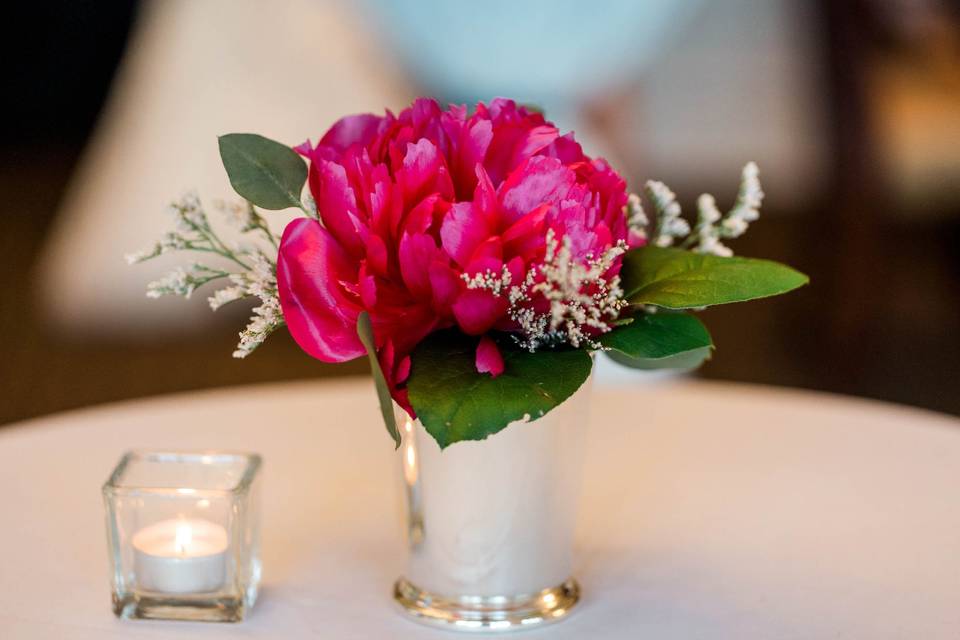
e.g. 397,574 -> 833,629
407,330 -> 593,449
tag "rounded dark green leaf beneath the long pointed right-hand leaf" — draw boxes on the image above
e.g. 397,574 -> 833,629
600,312 -> 713,369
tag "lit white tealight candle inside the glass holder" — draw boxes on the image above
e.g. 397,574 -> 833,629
132,519 -> 228,594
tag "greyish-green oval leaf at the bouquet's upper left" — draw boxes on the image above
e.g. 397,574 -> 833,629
218,133 -> 307,210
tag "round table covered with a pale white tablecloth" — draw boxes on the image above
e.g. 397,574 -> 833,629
0,379 -> 960,640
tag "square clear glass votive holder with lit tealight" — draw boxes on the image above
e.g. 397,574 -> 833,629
103,451 -> 260,622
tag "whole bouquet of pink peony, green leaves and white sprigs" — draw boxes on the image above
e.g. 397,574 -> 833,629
128,99 -> 807,447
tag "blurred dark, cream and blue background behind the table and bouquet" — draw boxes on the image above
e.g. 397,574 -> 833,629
0,0 -> 960,423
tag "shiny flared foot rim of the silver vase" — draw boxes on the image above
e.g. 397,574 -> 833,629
393,578 -> 580,633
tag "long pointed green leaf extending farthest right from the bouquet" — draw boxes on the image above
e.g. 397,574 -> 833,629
620,247 -> 809,309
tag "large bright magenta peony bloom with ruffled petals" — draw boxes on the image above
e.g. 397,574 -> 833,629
277,99 -> 628,414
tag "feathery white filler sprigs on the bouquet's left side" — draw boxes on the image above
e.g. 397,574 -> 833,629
126,192 -> 284,358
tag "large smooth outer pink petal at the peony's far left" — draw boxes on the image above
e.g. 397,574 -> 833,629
277,218 -> 365,362
